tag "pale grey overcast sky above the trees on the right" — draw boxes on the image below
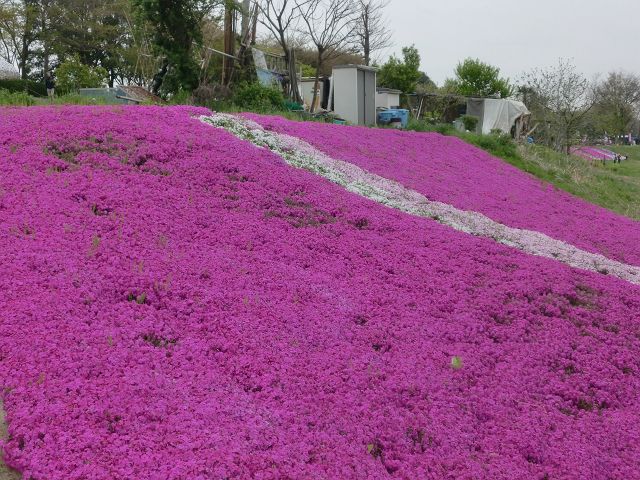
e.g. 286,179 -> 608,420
382,0 -> 640,85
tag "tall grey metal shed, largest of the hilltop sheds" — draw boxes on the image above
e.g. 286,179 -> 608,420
333,65 -> 377,125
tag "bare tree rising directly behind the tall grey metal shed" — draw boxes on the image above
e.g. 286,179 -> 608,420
355,0 -> 393,65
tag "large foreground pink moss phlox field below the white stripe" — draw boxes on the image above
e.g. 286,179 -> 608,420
0,107 -> 640,480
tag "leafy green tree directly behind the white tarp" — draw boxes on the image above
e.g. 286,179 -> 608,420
446,58 -> 514,98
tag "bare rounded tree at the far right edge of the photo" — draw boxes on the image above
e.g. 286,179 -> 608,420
594,72 -> 640,141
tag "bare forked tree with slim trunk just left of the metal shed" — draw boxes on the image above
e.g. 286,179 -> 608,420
296,0 -> 357,112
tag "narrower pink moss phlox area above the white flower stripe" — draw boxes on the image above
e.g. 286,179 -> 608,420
246,114 -> 640,265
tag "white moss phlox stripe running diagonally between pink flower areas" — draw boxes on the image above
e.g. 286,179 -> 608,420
200,113 -> 640,285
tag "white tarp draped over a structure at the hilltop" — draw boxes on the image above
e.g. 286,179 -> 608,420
467,98 -> 530,135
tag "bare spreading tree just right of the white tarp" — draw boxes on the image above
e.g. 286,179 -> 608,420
523,59 -> 596,154
